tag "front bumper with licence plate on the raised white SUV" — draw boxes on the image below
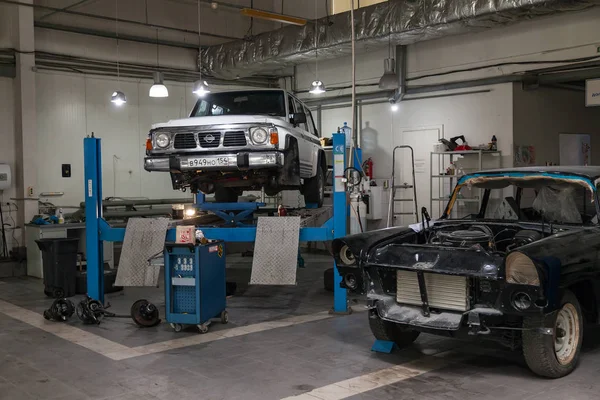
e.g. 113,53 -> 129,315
144,151 -> 284,172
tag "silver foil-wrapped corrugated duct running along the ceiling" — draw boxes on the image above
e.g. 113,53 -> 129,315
202,0 -> 600,79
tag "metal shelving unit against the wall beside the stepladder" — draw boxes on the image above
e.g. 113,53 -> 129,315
429,150 -> 502,217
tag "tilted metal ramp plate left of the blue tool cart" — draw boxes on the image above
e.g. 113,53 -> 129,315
115,218 -> 169,286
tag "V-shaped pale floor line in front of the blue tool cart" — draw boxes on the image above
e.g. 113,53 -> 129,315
0,300 -> 346,361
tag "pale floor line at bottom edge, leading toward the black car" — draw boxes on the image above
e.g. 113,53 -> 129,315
281,350 -> 464,400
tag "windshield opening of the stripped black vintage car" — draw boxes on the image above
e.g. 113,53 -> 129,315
451,179 -> 597,224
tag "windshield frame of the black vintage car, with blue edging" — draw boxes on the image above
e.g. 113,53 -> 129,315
441,171 -> 600,225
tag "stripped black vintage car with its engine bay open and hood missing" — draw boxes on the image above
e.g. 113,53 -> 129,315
333,167 -> 600,377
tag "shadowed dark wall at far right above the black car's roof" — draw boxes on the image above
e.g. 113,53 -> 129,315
513,85 -> 600,165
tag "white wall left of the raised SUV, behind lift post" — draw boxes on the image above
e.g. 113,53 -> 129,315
36,73 -> 195,206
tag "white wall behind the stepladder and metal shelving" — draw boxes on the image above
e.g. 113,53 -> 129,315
314,83 -> 513,228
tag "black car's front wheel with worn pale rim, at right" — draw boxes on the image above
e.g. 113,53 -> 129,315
523,290 -> 583,378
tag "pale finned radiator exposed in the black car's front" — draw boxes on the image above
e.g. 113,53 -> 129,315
396,270 -> 469,311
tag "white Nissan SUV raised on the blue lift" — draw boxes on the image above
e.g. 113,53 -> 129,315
144,89 -> 327,207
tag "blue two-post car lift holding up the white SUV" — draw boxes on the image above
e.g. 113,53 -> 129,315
83,133 -> 351,313
